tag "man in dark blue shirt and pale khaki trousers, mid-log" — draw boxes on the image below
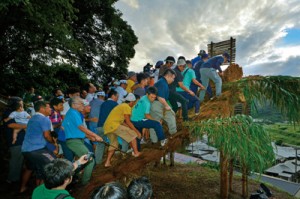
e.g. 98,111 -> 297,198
150,69 -> 177,143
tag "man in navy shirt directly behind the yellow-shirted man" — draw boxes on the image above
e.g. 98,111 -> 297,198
95,89 -> 119,164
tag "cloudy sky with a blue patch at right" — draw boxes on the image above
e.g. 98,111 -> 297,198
115,0 -> 300,76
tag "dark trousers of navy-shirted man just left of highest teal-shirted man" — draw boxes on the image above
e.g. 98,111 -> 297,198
169,92 -> 188,121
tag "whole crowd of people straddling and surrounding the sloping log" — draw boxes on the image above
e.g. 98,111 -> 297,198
3,50 -> 230,198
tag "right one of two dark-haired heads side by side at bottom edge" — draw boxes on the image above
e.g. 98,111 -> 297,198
127,176 -> 153,199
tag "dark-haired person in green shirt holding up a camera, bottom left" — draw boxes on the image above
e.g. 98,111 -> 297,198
32,155 -> 88,199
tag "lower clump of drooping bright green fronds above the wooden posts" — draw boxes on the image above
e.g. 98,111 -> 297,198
185,115 -> 275,173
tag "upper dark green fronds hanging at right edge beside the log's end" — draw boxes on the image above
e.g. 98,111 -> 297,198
237,76 -> 300,123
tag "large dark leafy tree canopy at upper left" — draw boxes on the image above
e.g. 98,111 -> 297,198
0,0 -> 138,95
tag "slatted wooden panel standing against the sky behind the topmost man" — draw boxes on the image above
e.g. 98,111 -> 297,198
207,37 -> 236,64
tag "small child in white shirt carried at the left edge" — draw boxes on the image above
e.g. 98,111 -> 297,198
4,103 -> 31,144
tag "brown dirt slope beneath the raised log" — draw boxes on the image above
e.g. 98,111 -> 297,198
0,160 -> 294,199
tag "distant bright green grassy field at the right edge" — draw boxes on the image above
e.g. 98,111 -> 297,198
264,123 -> 300,146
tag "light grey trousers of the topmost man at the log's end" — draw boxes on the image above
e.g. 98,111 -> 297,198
199,68 -> 222,102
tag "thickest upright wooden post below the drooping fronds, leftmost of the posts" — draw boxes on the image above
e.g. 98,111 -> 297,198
220,150 -> 228,199
